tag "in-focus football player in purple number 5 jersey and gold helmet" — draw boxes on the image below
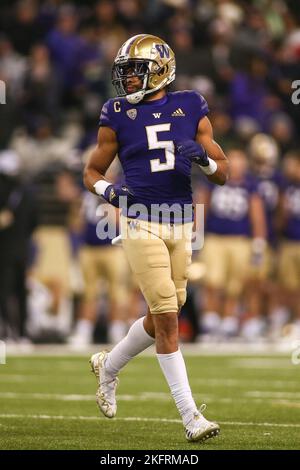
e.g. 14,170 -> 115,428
84,34 -> 228,441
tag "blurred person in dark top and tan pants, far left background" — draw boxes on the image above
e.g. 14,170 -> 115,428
29,164 -> 80,341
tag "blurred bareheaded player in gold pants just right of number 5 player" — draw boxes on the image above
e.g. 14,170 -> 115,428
198,149 -> 266,338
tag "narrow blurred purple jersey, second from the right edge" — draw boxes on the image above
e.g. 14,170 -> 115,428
257,172 -> 283,244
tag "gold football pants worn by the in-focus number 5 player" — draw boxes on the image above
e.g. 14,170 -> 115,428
121,216 -> 193,314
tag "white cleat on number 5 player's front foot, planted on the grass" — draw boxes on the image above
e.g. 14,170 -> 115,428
185,404 -> 220,442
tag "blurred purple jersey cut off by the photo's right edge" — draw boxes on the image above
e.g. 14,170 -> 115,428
283,182 -> 300,241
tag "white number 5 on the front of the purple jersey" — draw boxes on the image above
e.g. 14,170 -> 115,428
146,123 -> 175,173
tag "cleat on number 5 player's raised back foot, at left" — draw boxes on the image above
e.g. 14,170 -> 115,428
90,351 -> 119,418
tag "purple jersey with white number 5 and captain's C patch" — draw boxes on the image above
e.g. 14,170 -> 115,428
100,91 -> 208,222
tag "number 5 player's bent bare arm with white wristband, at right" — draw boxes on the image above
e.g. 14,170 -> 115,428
196,116 -> 229,185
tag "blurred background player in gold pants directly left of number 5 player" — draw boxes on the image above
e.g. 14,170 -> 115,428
69,178 -> 128,345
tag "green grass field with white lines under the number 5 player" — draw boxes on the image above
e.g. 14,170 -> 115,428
0,355 -> 300,450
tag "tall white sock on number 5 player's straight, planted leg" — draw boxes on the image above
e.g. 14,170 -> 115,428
156,349 -> 197,425
